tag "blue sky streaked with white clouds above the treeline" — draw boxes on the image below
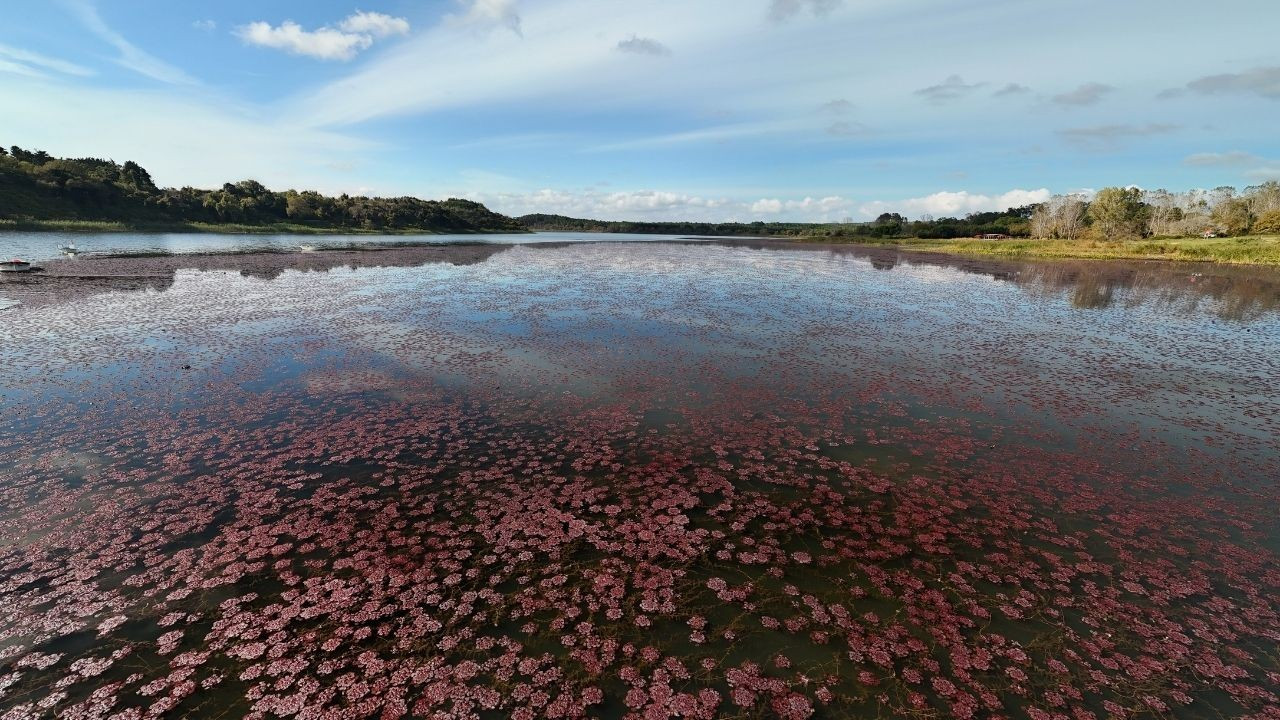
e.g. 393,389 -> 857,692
0,0 -> 1280,220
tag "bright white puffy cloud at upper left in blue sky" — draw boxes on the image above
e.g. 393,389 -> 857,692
236,12 -> 408,60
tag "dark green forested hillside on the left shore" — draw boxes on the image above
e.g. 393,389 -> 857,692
0,146 -> 525,233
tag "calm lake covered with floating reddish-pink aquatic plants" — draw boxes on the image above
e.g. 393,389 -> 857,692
0,234 -> 1280,719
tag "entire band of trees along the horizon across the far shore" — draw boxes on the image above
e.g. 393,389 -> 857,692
0,146 -> 1280,241
